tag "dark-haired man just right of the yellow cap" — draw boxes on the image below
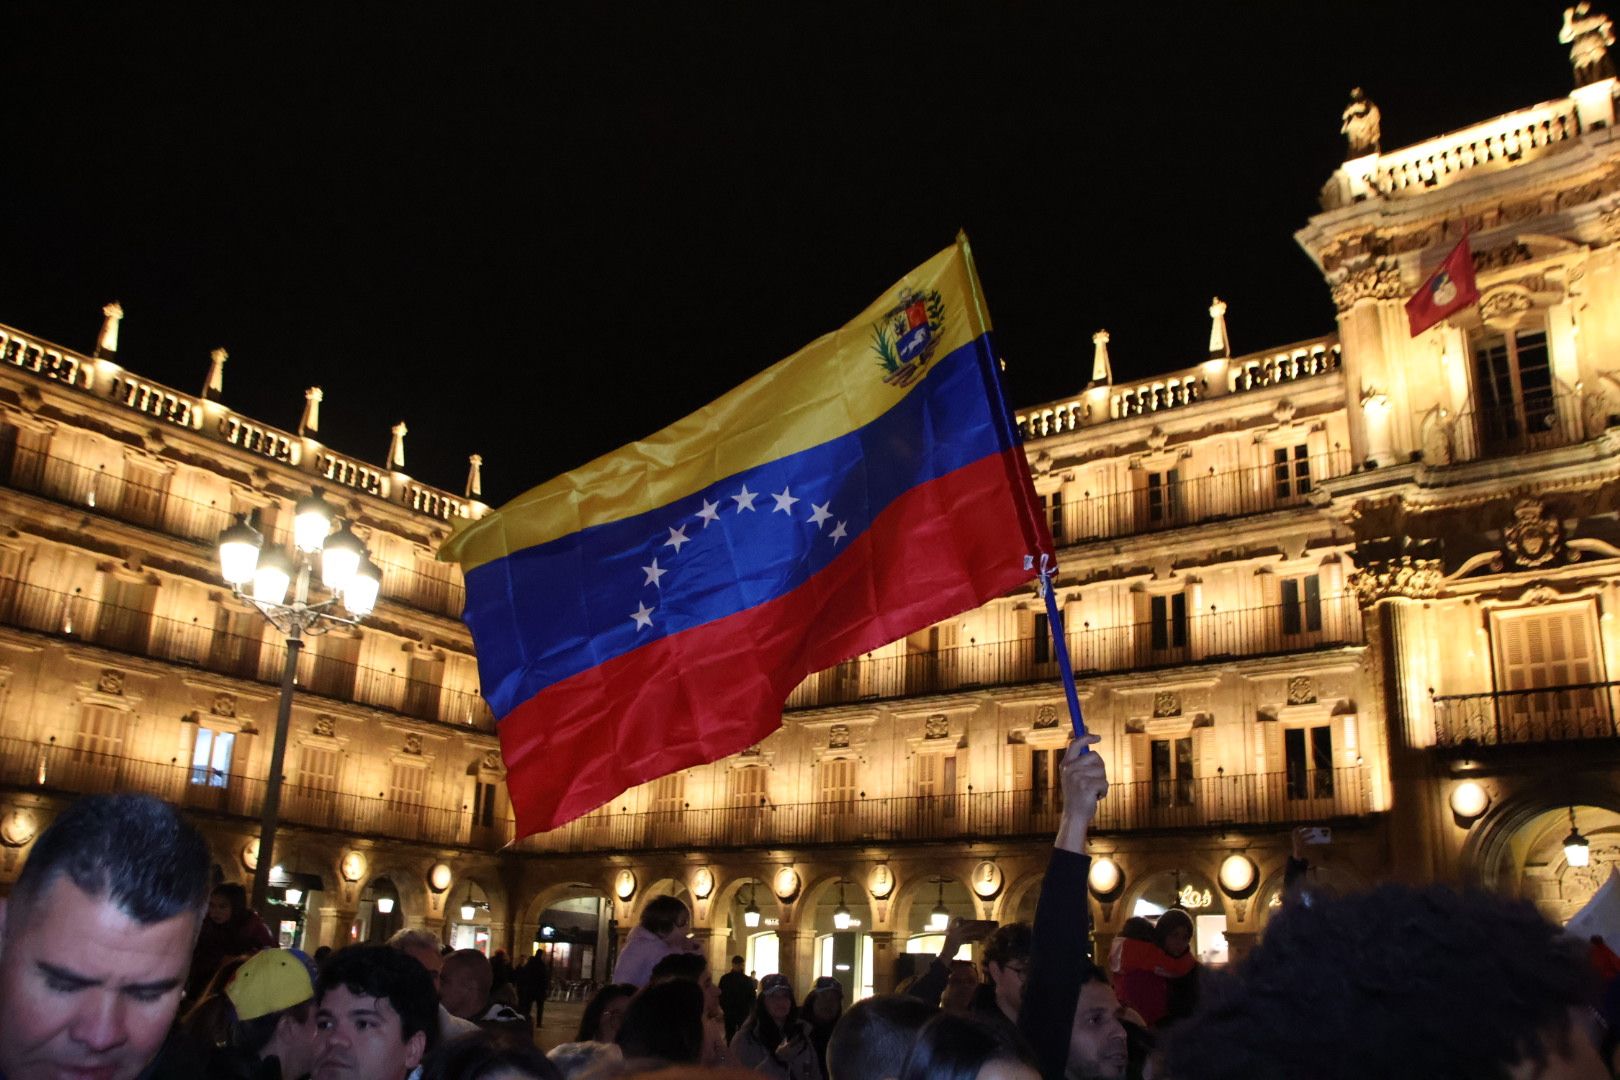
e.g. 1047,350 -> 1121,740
313,946 -> 439,1080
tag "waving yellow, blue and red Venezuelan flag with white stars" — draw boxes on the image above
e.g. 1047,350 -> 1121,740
439,238 -> 1051,836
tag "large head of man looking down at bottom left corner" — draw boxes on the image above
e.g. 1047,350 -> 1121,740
0,795 -> 212,1080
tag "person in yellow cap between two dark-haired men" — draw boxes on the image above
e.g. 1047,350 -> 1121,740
222,949 -> 314,1080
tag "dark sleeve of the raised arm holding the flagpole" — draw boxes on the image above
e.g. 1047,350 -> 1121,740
1017,848 -> 1092,1080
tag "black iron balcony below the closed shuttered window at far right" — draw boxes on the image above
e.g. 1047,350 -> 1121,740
1434,682 -> 1620,746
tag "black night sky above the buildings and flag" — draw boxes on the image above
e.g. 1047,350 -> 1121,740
0,0 -> 1568,502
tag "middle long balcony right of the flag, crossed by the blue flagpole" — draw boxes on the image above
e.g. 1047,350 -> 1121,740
786,593 -> 1366,709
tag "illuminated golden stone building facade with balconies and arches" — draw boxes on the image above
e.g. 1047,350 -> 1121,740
0,23 -> 1620,993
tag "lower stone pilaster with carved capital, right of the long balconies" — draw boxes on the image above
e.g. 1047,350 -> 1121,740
1351,555 -> 1450,884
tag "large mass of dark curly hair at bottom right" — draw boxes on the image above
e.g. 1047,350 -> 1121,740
1168,886 -> 1594,1080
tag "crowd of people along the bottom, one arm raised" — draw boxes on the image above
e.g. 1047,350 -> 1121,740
0,737 -> 1620,1080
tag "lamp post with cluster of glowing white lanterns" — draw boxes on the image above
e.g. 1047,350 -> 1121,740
219,487 -> 382,910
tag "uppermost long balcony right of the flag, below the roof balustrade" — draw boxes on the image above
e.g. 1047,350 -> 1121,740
1047,450 -> 1351,547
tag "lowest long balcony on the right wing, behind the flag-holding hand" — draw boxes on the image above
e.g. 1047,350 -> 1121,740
520,767 -> 1371,853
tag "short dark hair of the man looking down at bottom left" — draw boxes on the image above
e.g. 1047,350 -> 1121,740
6,795 -> 212,931
